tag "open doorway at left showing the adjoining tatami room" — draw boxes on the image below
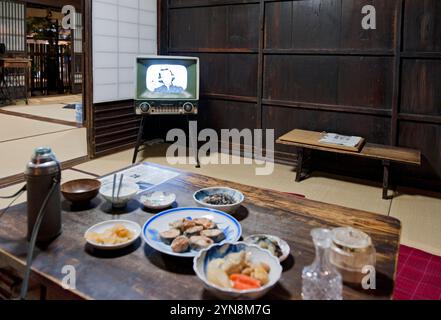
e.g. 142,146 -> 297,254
0,0 -> 88,186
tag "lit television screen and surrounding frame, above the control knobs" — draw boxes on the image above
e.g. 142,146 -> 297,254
135,56 -> 199,100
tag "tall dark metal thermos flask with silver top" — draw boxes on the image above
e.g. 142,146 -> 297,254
25,147 -> 61,242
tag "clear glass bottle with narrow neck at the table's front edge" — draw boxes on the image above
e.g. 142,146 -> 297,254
302,228 -> 343,300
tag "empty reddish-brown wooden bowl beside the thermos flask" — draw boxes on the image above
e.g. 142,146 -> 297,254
61,179 -> 101,203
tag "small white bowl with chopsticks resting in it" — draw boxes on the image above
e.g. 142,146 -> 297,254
100,179 -> 139,208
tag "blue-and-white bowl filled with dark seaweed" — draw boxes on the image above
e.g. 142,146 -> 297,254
193,187 -> 245,214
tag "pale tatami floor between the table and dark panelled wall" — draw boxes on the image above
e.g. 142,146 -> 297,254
75,145 -> 441,255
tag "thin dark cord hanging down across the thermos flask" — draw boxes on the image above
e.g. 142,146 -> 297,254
20,175 -> 60,300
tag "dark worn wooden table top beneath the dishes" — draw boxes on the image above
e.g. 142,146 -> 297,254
0,162 -> 401,299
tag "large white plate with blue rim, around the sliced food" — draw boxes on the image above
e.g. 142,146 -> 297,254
142,208 -> 242,257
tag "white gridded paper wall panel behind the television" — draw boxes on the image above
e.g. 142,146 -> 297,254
92,0 -> 157,103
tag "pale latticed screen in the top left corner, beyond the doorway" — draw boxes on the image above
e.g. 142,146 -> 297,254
0,0 -> 26,52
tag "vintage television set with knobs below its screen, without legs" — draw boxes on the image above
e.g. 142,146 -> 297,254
135,56 -> 199,115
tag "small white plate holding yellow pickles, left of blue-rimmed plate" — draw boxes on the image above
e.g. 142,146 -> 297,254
84,220 -> 141,250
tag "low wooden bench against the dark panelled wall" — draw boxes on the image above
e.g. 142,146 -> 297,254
276,129 -> 421,199
